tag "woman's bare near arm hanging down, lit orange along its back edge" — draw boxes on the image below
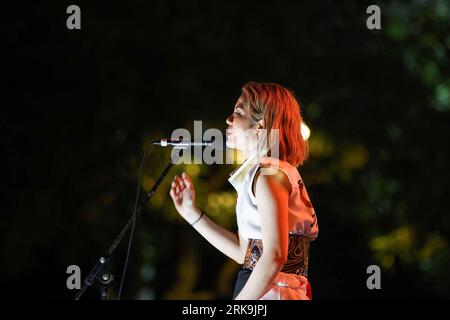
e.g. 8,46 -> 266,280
236,170 -> 290,300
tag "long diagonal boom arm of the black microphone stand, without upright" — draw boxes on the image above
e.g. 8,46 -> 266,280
74,153 -> 180,300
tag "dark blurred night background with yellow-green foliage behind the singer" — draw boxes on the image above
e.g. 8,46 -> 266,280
0,0 -> 450,299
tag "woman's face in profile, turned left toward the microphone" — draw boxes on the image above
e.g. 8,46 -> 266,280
226,96 -> 257,155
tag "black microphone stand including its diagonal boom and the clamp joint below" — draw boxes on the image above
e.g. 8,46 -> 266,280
74,148 -> 184,300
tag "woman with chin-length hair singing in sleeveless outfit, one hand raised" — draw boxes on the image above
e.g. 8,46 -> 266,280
170,82 -> 318,300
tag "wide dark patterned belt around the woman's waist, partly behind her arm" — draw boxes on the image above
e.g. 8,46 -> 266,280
242,233 -> 310,277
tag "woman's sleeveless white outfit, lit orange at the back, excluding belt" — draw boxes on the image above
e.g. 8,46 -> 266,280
228,156 -> 319,300
